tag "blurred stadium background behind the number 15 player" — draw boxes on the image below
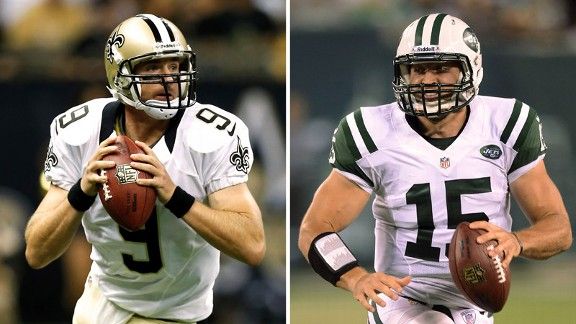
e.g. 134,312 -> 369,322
289,0 -> 576,324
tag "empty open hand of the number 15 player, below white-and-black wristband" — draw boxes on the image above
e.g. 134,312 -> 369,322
340,267 -> 411,312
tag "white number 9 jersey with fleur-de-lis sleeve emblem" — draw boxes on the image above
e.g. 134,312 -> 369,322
45,99 -> 253,322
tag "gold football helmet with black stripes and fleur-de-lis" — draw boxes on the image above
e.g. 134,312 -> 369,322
104,14 -> 196,119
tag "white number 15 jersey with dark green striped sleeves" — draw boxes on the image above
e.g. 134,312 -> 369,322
330,96 -> 546,308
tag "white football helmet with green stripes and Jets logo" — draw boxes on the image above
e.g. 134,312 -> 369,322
392,13 -> 483,118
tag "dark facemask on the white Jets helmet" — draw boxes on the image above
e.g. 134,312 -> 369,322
393,53 -> 476,118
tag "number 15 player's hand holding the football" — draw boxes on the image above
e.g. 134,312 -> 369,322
470,221 -> 521,268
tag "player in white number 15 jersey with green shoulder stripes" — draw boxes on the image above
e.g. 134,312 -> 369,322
298,14 -> 572,324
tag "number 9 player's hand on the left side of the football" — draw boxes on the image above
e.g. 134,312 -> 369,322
80,136 -> 118,196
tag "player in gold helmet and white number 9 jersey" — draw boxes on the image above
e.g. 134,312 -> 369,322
26,14 -> 265,324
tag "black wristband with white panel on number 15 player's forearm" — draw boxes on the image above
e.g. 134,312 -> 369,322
308,232 -> 358,286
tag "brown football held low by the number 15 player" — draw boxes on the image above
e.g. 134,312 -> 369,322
448,222 -> 510,313
